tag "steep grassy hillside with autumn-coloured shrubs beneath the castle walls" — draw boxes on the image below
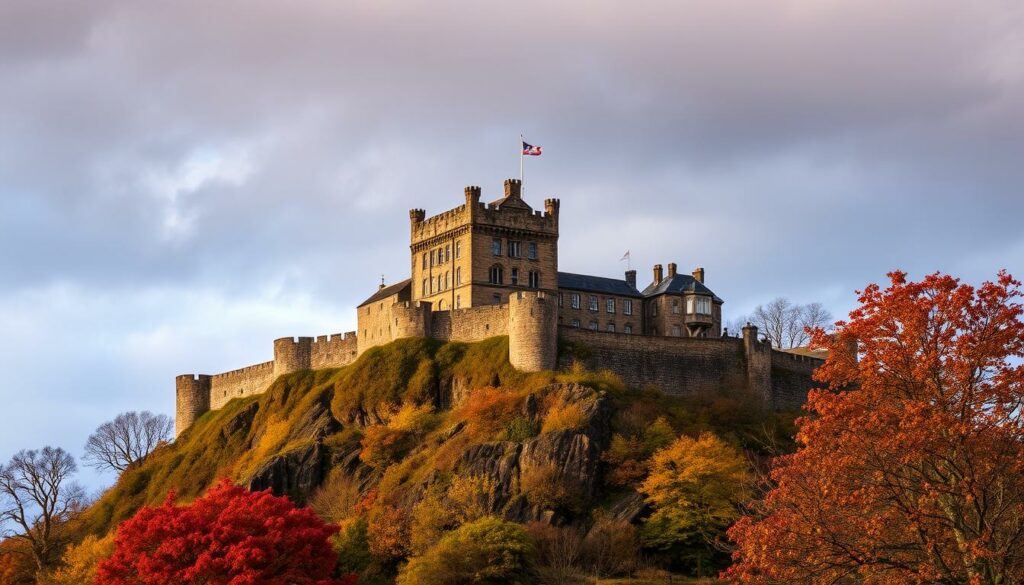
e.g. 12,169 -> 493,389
70,337 -> 794,581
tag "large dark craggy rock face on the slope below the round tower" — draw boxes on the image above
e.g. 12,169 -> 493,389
446,384 -> 610,521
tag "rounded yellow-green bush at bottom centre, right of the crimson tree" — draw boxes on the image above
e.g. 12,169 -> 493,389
397,516 -> 534,585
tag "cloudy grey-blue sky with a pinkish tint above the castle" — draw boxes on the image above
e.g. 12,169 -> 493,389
6,0 -> 1024,489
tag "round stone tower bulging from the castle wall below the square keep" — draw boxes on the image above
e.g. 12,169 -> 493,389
509,291 -> 558,372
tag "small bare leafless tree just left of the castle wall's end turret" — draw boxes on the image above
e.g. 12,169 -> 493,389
84,411 -> 174,472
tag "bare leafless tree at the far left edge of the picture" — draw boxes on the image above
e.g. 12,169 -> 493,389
0,447 -> 84,572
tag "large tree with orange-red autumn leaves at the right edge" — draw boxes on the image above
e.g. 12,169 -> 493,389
724,271 -> 1024,585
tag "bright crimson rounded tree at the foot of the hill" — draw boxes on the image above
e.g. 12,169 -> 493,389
95,479 -> 355,585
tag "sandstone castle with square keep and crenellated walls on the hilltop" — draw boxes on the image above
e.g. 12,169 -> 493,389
175,179 -> 821,434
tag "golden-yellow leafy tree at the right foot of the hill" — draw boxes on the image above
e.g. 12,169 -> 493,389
640,432 -> 754,576
